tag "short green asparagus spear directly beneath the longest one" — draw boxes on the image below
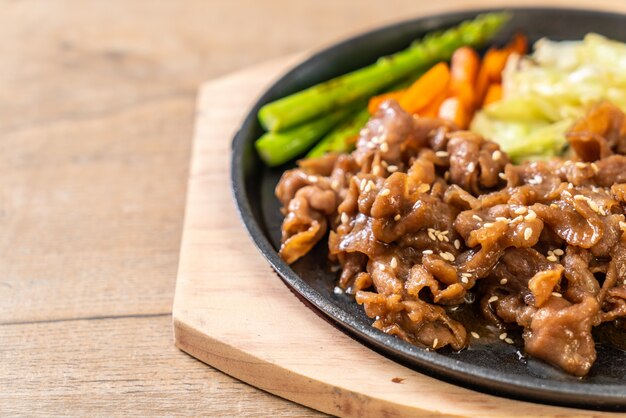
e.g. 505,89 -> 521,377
254,106 -> 355,167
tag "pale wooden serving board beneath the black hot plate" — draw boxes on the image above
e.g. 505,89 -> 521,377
173,55 -> 620,417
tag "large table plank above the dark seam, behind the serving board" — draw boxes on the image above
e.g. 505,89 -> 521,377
0,0 -> 623,322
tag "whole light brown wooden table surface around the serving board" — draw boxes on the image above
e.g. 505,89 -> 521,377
0,0 -> 622,416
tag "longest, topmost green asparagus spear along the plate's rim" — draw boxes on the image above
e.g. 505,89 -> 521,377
258,13 -> 509,131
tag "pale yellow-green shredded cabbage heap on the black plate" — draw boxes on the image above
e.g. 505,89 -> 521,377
471,33 -> 626,161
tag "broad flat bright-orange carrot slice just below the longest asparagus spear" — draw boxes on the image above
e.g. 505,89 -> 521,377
400,62 -> 450,113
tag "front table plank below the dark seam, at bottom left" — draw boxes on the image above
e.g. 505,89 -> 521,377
0,315 -> 320,417
